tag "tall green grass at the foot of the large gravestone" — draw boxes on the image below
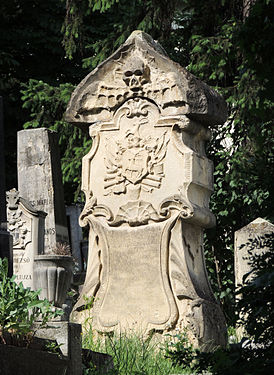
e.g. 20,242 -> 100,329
83,330 -> 191,375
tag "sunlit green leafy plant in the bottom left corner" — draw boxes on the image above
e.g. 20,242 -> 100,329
0,258 -> 61,343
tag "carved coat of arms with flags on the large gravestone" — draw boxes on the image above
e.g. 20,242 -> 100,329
104,103 -> 169,195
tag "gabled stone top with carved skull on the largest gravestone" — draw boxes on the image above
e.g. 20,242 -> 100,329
65,31 -> 227,128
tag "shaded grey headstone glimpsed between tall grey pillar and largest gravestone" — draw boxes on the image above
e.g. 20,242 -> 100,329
66,205 -> 83,272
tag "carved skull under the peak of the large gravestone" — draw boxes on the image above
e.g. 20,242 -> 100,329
123,57 -> 150,91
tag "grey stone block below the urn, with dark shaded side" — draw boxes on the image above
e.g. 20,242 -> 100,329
35,322 -> 82,375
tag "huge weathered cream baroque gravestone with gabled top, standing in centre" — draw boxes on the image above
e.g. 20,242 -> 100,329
66,31 -> 226,345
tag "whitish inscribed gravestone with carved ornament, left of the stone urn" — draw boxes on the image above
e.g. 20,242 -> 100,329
7,189 -> 46,290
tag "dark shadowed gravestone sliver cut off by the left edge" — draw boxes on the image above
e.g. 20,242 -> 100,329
0,96 -> 13,276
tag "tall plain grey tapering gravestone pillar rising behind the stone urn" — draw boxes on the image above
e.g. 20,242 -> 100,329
17,128 -> 69,254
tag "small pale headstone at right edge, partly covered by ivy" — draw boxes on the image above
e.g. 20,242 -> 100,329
234,218 -> 274,288
